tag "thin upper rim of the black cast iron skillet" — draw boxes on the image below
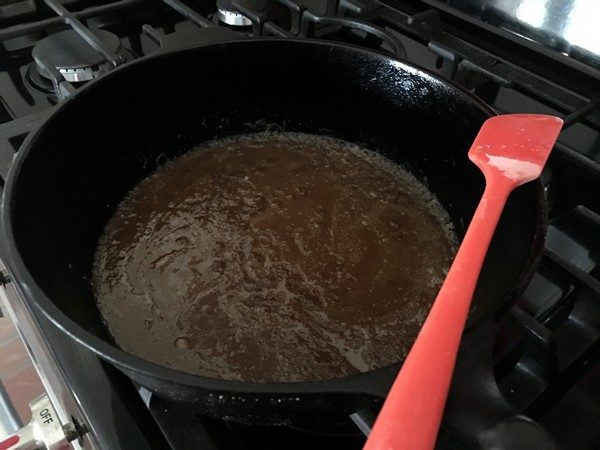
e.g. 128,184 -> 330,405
1,37 -> 545,395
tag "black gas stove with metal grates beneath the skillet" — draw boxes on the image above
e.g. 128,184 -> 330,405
0,0 -> 600,449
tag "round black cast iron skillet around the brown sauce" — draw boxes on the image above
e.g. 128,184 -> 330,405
2,39 -> 545,424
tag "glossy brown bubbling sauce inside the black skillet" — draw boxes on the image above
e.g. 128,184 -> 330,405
93,133 -> 456,382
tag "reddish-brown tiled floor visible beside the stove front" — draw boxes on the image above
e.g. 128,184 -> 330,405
0,317 -> 44,438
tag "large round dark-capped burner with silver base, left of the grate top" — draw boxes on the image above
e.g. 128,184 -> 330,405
31,30 -> 121,82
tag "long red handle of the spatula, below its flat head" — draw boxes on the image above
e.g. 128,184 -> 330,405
364,176 -> 514,450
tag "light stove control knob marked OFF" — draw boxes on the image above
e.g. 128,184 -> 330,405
0,395 -> 78,450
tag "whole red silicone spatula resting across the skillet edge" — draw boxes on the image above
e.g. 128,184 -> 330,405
364,114 -> 563,450
